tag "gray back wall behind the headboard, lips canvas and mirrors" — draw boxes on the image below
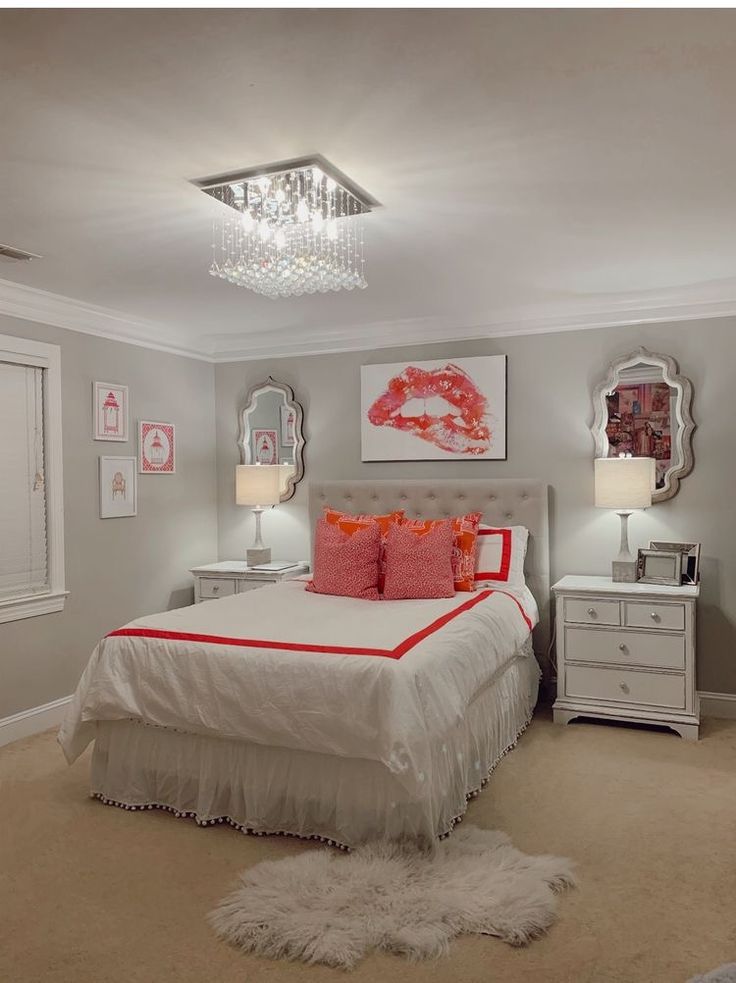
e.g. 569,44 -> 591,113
215,318 -> 736,693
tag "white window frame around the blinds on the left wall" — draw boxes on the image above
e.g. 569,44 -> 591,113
0,335 -> 69,624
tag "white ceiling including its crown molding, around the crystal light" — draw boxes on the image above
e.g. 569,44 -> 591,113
0,9 -> 736,359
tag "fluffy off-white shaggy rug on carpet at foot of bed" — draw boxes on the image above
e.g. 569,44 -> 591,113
209,826 -> 574,969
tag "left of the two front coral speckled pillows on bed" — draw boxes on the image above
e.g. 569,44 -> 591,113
306,519 -> 381,601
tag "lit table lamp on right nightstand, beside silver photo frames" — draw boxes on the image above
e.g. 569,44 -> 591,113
595,457 -> 655,584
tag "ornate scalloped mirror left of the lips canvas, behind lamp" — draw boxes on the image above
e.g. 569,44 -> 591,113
238,376 -> 304,502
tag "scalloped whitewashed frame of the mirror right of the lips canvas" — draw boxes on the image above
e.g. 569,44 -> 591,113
590,348 -> 695,504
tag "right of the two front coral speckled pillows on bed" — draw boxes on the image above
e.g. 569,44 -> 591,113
383,519 -> 455,601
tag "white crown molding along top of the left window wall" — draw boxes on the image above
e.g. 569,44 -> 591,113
0,280 -> 212,362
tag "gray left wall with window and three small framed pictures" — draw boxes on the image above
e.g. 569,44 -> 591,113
0,317 -> 217,718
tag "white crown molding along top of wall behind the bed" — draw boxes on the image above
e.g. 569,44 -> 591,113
211,300 -> 736,363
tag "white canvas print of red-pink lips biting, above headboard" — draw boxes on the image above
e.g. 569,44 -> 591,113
360,355 -> 506,461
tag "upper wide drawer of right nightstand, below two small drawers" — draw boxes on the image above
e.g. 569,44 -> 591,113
565,628 -> 685,669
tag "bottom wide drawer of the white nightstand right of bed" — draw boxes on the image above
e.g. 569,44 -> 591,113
565,666 -> 685,710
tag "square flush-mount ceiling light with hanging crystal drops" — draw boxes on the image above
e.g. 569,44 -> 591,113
194,156 -> 378,299
